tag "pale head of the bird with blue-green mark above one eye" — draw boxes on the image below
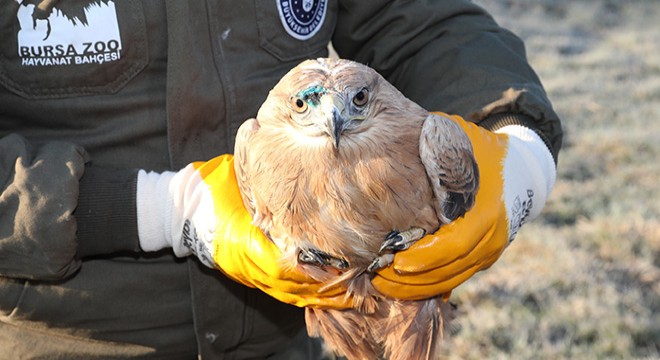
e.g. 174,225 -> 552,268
258,59 -> 397,149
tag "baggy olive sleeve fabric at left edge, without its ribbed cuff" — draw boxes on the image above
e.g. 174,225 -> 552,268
0,134 -> 88,280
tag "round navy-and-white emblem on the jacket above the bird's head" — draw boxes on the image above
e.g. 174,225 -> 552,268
276,0 -> 328,40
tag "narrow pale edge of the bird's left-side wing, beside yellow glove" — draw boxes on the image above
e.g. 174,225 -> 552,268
234,119 -> 259,217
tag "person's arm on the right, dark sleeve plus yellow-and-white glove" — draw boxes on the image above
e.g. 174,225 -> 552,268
333,1 -> 562,298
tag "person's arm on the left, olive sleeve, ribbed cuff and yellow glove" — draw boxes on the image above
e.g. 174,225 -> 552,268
0,134 -> 346,307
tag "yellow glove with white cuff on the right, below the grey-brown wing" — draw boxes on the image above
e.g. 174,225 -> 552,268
372,114 -> 556,300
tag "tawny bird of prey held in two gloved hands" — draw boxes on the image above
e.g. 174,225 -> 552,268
235,58 -> 479,359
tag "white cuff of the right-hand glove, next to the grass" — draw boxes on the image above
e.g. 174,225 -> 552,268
496,125 -> 557,242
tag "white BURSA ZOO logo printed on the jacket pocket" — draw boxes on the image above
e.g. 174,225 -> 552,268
17,1 -> 122,66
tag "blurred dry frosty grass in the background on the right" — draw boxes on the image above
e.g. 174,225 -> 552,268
447,0 -> 660,359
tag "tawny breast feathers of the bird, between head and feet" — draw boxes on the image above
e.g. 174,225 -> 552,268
250,128 -> 438,263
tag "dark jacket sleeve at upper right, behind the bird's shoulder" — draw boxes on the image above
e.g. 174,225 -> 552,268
333,0 -> 562,159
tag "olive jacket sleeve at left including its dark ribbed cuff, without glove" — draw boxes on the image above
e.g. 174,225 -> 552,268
0,134 -> 137,280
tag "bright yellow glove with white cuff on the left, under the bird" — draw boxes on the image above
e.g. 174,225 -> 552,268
137,155 -> 350,308
